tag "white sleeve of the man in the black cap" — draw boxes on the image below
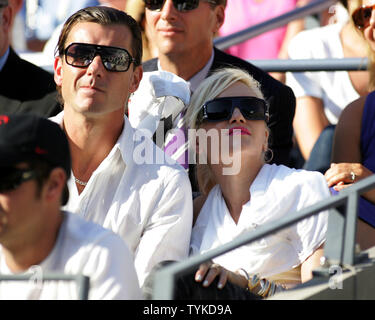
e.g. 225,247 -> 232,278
83,234 -> 143,300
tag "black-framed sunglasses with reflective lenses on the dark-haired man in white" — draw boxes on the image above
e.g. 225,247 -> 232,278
64,42 -> 136,72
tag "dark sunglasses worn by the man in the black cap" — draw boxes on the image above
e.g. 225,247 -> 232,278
0,167 -> 37,192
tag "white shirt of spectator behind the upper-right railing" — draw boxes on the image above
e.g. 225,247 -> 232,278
286,24 -> 359,124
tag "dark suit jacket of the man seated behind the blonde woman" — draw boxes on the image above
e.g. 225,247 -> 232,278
143,48 -> 296,166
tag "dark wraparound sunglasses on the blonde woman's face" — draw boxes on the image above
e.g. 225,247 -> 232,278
198,97 -> 269,122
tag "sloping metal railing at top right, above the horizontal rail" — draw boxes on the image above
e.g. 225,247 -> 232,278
214,0 -> 337,50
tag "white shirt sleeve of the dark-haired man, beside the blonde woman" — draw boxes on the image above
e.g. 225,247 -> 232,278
135,170 -> 193,287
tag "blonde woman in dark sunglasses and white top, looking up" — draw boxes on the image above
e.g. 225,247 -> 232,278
186,68 -> 330,296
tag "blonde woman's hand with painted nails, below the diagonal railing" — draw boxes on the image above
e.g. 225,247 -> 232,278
195,261 -> 248,289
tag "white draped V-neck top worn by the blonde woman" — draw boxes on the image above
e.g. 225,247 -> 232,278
191,164 -> 330,280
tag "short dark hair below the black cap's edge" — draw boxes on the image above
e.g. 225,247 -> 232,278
26,159 -> 69,206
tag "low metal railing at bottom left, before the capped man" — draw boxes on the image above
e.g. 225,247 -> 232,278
0,273 -> 90,300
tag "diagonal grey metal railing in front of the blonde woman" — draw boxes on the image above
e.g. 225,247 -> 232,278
153,175 -> 375,300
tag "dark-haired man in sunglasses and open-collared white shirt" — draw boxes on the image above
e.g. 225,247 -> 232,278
53,6 -> 192,285
